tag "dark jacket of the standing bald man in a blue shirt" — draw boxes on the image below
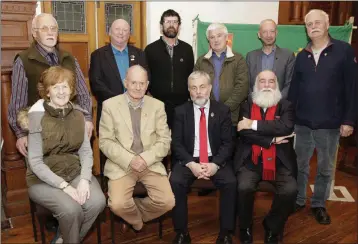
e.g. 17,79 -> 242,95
89,44 -> 148,131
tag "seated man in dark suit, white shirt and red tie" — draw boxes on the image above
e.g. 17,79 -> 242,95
170,71 -> 236,244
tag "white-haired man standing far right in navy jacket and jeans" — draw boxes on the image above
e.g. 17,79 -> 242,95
288,9 -> 358,224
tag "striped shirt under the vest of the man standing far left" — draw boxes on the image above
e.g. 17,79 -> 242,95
8,44 -> 92,138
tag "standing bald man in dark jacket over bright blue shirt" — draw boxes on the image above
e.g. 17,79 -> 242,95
89,19 -> 148,133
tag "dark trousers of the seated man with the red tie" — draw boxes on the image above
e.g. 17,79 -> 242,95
169,163 -> 237,234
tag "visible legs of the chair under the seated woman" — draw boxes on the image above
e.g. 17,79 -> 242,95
29,198 -> 101,244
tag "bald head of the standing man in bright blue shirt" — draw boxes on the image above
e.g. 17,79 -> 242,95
109,19 -> 131,48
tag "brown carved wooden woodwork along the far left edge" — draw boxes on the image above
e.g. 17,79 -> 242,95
1,1 -> 36,217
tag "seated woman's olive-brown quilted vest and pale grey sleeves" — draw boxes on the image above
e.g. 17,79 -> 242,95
20,99 -> 93,188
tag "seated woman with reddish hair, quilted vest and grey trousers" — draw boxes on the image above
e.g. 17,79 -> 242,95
18,66 -> 106,243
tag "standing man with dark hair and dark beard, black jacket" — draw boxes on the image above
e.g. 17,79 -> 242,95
144,9 -> 194,128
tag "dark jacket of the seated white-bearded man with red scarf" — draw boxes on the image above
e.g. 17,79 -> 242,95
234,99 -> 297,177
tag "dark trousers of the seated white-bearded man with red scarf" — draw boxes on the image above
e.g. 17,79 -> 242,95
237,165 -> 297,234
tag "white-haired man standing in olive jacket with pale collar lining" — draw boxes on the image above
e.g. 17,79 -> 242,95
194,23 -> 249,137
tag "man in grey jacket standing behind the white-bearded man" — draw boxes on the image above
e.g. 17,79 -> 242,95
246,19 -> 295,98
